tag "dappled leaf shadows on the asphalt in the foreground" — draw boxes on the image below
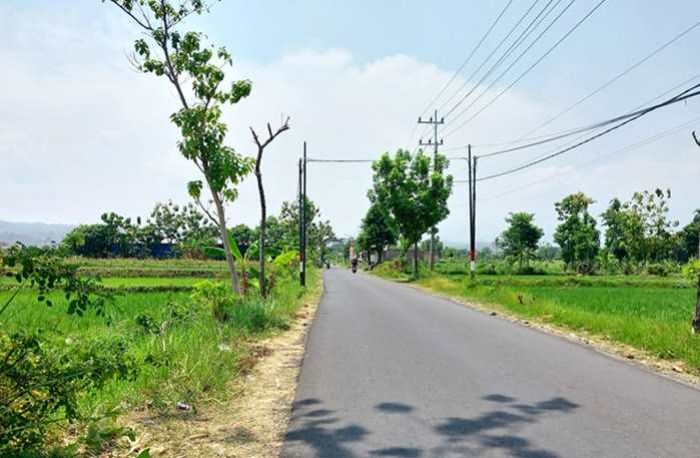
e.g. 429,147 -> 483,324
282,394 -> 579,458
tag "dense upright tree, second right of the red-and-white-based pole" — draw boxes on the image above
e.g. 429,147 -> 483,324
554,192 -> 600,274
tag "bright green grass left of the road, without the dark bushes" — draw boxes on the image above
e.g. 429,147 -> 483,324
0,260 -> 321,450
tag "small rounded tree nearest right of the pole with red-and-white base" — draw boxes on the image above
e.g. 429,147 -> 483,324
496,212 -> 544,270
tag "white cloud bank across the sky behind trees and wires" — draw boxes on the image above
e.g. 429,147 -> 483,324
0,7 -> 700,242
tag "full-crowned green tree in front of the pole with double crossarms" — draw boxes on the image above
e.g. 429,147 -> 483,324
368,150 -> 452,276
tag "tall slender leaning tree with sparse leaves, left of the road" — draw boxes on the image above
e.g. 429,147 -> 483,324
108,0 -> 253,294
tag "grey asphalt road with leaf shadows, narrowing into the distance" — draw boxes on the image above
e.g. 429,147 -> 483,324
282,270 -> 700,458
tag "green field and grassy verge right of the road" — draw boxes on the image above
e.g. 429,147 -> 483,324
374,264 -> 700,375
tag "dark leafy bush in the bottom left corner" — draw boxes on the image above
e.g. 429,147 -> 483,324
0,333 -> 135,456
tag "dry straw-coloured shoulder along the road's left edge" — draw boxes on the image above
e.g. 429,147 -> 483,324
122,281 -> 323,458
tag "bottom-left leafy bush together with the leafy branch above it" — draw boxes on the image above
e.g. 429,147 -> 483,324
0,247 -> 134,456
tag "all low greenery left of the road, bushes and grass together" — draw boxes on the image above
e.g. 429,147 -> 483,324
0,238 -> 320,456
